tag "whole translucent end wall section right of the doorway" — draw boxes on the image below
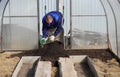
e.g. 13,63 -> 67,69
71,0 -> 108,49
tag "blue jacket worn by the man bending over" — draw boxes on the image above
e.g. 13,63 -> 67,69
42,11 -> 63,38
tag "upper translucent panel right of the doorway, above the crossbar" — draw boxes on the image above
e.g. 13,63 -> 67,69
72,0 -> 105,15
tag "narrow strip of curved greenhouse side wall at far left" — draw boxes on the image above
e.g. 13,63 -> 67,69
0,0 -> 8,50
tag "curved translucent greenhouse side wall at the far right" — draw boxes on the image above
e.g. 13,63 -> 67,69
101,0 -> 120,57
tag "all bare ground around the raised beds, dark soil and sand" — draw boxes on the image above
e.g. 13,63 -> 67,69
0,42 -> 120,77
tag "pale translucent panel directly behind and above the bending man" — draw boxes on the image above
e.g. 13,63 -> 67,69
39,0 -> 58,35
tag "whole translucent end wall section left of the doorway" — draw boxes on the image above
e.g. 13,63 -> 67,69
2,0 -> 38,50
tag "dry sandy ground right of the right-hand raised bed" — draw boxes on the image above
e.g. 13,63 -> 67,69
93,59 -> 120,77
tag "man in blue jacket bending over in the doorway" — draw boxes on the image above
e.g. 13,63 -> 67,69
41,11 -> 63,45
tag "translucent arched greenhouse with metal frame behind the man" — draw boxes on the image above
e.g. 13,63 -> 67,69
0,0 -> 120,77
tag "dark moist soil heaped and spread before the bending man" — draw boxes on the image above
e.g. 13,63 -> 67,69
11,42 -> 113,66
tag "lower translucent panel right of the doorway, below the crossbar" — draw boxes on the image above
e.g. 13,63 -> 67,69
72,16 -> 107,49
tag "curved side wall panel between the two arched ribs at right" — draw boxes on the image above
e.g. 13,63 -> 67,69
101,0 -> 117,55
